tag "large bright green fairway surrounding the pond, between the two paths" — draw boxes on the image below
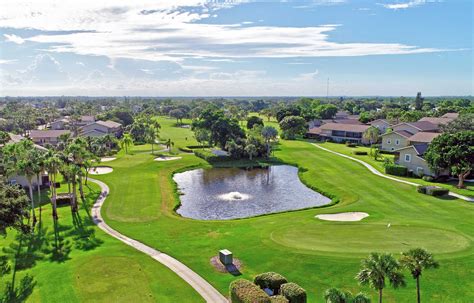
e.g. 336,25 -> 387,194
93,118 -> 474,302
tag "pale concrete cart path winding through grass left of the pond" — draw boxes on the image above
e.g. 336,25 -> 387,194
89,179 -> 229,303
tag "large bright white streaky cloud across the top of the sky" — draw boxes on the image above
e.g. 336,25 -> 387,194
0,0 -> 448,66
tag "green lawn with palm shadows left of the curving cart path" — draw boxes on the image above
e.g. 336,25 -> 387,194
0,179 -> 203,302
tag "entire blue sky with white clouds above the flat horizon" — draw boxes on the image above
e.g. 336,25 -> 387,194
0,0 -> 474,96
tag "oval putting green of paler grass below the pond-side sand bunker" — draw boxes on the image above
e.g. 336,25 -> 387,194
271,224 -> 471,255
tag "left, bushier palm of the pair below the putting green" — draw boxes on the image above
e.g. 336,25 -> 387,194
356,253 -> 405,303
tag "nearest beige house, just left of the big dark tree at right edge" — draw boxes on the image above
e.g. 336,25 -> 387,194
395,144 -> 436,177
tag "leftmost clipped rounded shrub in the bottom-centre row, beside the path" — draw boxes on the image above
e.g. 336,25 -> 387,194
229,279 -> 271,303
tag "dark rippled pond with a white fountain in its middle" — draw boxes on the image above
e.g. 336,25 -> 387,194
173,165 -> 331,220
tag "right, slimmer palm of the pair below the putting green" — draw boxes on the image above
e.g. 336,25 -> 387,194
400,248 -> 439,303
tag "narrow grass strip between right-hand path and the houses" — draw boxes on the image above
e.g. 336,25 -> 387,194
318,142 -> 474,197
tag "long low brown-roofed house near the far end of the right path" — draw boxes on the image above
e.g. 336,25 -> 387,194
306,122 -> 370,144
